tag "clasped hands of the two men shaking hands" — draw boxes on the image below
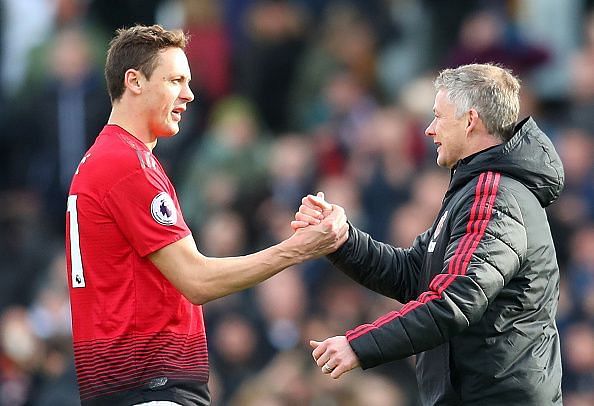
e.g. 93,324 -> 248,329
287,192 -> 349,260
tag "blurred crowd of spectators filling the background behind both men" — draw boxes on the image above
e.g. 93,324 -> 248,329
0,0 -> 594,406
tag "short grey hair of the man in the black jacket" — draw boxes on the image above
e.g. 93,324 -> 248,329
434,64 -> 520,142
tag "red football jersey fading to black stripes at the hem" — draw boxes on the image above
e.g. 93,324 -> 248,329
66,125 -> 209,405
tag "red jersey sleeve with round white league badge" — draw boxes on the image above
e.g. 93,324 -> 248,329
103,169 -> 190,257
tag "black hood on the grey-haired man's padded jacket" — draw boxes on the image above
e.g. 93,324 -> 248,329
446,117 -> 565,207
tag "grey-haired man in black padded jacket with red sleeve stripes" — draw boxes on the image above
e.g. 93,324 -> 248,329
292,64 -> 564,406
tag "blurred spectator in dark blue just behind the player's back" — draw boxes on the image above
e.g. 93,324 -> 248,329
14,26 -> 110,235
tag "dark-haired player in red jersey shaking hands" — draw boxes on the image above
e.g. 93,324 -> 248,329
66,25 -> 348,405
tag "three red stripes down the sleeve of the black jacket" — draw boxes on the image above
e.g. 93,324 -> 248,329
346,172 -> 501,341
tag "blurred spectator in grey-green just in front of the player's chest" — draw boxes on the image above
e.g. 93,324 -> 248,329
180,97 -> 269,226
